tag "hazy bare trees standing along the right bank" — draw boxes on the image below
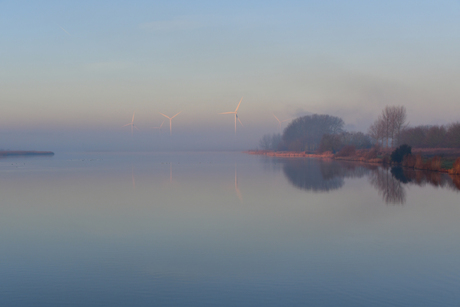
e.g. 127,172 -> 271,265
259,106 -> 460,153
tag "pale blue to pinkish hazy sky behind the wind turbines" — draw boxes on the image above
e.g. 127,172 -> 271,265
0,0 -> 460,151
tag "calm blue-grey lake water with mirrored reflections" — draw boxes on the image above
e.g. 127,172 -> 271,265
0,153 -> 460,306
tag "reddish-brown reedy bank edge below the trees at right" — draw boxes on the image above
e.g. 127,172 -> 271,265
243,150 -> 460,175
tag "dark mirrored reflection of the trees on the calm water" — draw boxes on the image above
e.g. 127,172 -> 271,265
267,159 -> 460,204
